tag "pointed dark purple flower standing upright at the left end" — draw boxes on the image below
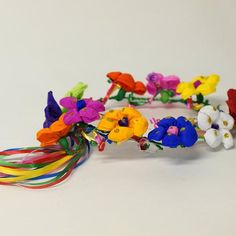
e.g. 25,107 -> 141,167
43,91 -> 62,128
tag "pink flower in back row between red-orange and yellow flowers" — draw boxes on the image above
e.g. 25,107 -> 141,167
146,72 -> 180,96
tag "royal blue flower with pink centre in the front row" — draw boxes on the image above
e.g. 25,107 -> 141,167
148,116 -> 198,148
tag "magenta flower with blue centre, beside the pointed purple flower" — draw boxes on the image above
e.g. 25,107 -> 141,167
60,97 -> 105,125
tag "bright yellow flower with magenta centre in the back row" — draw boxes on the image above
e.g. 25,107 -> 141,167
176,74 -> 220,99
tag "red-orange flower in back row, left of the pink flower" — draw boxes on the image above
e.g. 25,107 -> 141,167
107,72 -> 146,95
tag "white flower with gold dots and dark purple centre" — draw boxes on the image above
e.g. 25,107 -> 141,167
197,105 -> 234,149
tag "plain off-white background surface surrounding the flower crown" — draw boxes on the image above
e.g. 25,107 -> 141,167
0,0 -> 236,236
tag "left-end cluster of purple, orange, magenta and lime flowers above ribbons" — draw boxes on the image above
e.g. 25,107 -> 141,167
37,83 -> 105,146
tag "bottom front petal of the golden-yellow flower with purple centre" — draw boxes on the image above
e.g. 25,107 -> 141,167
108,126 -> 134,142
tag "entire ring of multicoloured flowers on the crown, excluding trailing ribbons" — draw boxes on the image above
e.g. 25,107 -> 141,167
37,72 -> 236,153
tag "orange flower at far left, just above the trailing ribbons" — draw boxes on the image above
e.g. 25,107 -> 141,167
37,115 -> 71,147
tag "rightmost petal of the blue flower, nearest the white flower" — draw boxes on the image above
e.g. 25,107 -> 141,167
179,125 -> 198,147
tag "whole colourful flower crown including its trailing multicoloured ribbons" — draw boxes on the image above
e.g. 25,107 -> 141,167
0,72 -> 236,189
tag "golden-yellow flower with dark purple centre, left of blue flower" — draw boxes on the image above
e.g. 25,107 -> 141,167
97,107 -> 148,142
